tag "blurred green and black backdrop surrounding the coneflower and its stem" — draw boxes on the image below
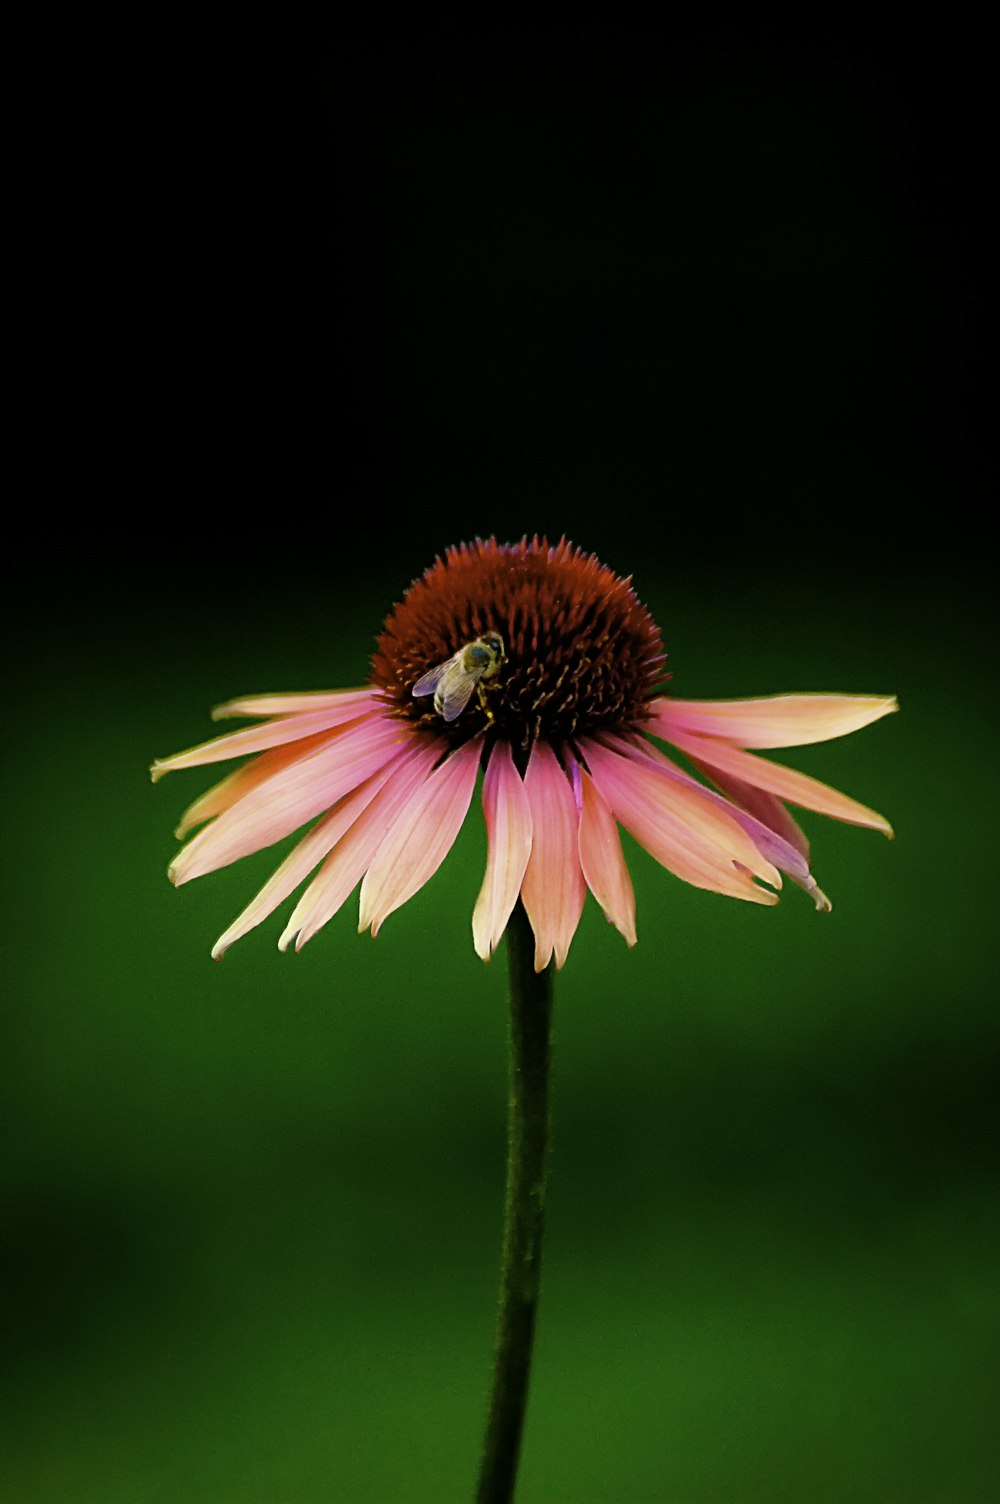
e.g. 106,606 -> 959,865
0,21 -> 1000,1504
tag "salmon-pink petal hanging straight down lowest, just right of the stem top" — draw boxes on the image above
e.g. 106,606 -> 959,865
520,741 -> 586,972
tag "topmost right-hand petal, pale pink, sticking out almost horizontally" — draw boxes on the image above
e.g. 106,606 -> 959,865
650,695 -> 899,747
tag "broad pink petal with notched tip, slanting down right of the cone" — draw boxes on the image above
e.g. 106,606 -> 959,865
580,740 -> 782,904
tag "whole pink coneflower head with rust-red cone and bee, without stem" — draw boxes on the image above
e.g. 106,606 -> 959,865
152,538 -> 896,970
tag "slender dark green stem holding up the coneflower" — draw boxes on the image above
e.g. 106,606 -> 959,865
477,899 -> 552,1504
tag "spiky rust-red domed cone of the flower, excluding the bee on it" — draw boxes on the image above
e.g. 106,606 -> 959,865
371,538 -> 665,750
